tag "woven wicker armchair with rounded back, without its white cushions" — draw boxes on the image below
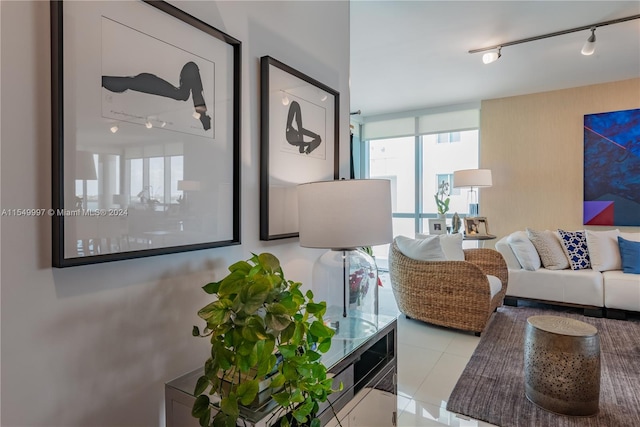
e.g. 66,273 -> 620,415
389,241 -> 508,335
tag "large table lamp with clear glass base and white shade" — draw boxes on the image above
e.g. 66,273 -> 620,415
298,179 -> 393,339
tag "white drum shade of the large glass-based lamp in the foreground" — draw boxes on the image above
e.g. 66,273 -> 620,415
298,179 -> 393,249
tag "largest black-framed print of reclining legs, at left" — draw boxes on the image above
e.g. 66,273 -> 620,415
50,1 -> 241,267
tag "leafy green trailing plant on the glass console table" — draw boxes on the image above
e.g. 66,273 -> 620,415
192,253 -> 334,427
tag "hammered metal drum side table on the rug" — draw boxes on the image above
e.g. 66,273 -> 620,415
524,316 -> 600,416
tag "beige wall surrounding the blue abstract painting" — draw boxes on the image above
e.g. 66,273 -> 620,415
480,79 -> 640,242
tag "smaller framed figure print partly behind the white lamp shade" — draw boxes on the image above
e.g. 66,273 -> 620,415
260,56 -> 340,240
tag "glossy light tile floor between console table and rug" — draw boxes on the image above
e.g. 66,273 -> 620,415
379,274 -> 492,427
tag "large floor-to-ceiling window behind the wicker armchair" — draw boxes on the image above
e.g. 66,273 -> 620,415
360,110 -> 479,264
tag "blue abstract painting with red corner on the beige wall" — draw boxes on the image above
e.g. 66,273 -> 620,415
584,109 -> 640,226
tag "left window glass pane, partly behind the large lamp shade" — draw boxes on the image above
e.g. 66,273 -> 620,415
369,137 -> 416,213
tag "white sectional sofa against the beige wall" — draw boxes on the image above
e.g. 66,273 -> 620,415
496,229 -> 640,317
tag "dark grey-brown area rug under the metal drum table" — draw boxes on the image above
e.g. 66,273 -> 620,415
447,307 -> 640,427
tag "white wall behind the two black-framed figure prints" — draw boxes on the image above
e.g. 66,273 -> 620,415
0,1 -> 349,427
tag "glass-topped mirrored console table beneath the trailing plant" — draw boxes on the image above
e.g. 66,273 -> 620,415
165,315 -> 398,427
